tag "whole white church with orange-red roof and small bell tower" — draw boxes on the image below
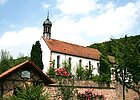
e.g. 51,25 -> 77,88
40,15 -> 101,74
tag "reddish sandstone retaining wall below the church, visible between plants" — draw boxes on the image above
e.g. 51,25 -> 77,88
46,80 -> 138,100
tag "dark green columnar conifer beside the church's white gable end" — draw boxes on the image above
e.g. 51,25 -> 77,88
31,41 -> 43,70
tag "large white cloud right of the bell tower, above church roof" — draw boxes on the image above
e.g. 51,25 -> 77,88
52,0 -> 140,45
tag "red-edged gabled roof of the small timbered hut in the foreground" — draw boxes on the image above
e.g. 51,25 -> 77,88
0,60 -> 54,84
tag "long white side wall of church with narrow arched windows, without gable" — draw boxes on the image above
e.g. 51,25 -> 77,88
52,53 -> 100,74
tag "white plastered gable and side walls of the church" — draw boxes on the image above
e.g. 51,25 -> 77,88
40,38 -> 100,74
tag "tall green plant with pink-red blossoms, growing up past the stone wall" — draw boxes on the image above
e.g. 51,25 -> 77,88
54,61 -> 77,100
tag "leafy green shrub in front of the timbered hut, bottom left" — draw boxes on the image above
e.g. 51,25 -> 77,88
4,85 -> 50,100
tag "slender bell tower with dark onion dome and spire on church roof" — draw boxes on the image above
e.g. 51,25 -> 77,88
43,12 -> 52,39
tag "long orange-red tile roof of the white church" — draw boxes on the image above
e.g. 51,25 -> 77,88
42,37 -> 101,60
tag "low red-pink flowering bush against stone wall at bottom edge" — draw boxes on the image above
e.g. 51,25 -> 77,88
77,90 -> 105,100
